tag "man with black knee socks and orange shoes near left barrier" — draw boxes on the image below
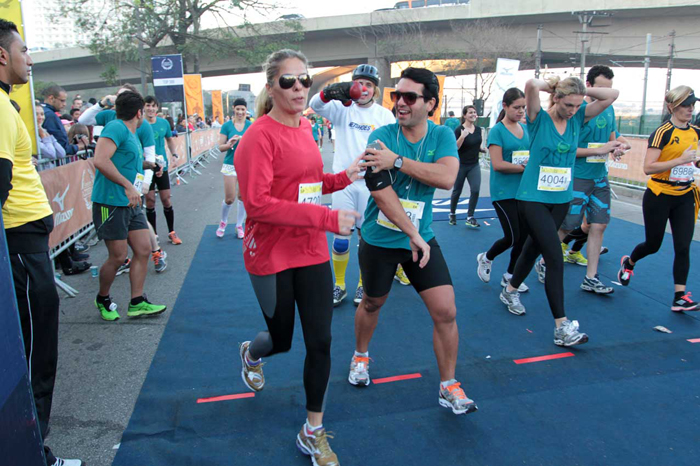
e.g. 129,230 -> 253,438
141,95 -> 182,245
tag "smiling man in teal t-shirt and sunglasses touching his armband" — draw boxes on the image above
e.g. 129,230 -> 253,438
348,68 -> 477,414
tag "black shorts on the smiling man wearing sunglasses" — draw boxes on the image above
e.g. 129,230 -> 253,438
358,238 -> 452,298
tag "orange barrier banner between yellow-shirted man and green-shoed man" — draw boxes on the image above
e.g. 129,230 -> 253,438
39,159 -> 95,248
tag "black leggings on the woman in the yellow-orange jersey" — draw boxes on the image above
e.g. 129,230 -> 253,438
630,189 -> 695,285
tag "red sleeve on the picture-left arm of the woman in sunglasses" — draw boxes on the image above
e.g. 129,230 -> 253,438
235,128 -> 340,233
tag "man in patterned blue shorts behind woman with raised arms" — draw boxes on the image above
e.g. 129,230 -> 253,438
559,65 -> 631,294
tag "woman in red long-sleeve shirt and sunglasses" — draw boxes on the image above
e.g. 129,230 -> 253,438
234,50 -> 360,466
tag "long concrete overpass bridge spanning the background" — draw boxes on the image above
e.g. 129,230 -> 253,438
32,0 -> 700,90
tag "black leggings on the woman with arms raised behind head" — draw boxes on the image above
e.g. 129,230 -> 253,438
510,201 -> 569,319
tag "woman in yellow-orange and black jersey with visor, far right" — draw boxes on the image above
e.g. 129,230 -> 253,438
617,86 -> 700,312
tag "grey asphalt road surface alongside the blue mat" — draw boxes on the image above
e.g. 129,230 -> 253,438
46,144 -> 700,466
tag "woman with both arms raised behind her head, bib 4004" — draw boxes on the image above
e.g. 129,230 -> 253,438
501,77 -> 619,346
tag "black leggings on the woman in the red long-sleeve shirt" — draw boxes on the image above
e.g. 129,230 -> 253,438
249,262 -> 333,413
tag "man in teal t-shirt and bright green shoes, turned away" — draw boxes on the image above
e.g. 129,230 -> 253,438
92,91 -> 165,321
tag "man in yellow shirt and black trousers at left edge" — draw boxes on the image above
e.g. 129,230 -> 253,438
0,19 -> 83,466
